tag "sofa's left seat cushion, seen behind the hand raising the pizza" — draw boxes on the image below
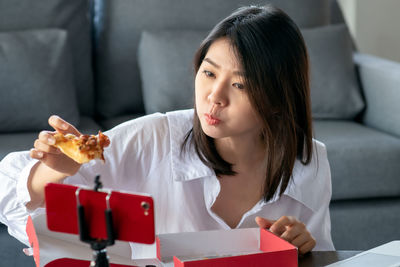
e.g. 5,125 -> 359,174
0,117 -> 102,160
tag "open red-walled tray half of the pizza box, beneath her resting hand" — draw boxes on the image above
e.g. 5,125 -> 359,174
156,228 -> 298,267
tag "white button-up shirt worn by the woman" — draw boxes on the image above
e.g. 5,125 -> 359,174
0,110 -> 334,258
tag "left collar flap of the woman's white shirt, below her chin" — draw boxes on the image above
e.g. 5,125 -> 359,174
167,109 -> 215,181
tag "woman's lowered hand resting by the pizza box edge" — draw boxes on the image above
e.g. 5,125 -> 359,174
256,216 -> 316,254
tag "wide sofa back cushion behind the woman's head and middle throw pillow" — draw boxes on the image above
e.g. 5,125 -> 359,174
94,0 -> 329,118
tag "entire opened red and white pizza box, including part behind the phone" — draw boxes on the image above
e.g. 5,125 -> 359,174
30,216 -> 298,267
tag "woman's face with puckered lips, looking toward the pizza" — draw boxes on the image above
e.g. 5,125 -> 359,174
195,38 -> 261,142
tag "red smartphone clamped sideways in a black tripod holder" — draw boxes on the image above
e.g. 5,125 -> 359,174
45,183 -> 155,244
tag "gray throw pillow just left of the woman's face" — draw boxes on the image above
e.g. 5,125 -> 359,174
138,31 -> 207,113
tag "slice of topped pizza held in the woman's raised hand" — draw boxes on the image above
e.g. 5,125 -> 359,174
54,131 -> 110,164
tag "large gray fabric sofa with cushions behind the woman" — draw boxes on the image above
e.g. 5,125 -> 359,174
0,0 -> 400,266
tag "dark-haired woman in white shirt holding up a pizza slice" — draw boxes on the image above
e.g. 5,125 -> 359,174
0,6 -> 333,258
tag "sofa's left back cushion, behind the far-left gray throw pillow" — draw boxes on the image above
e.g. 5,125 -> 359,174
0,0 -> 95,115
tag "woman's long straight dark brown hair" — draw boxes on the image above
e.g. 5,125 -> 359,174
182,5 -> 312,201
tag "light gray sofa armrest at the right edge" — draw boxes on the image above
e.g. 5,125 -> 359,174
353,53 -> 400,137
